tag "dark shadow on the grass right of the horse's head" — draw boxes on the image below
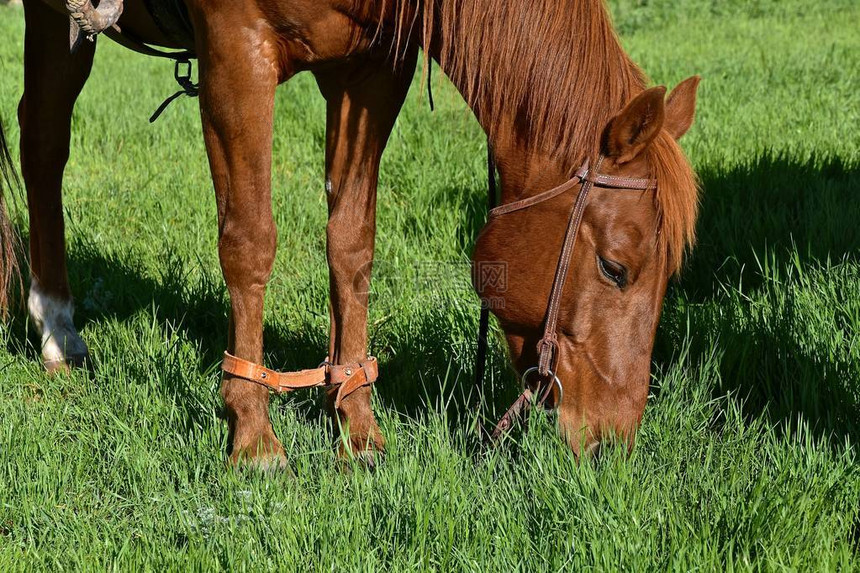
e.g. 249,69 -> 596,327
655,155 -> 860,443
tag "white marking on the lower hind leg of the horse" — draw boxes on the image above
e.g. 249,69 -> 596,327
27,278 -> 87,362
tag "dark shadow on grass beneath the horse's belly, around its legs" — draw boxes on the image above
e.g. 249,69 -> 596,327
1,237 -> 325,425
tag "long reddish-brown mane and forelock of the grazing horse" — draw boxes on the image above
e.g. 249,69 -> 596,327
360,0 -> 699,272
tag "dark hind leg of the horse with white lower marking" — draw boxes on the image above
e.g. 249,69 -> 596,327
18,0 -> 95,370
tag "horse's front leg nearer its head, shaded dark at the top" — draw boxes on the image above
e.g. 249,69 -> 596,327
316,51 -> 416,461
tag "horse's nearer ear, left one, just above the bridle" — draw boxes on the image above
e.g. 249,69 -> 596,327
605,86 -> 666,164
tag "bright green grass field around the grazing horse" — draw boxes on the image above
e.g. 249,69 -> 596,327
0,0 -> 860,571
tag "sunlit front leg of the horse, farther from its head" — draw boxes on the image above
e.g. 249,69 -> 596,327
195,14 -> 286,469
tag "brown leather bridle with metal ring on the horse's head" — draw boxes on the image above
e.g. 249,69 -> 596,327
476,151 -> 657,441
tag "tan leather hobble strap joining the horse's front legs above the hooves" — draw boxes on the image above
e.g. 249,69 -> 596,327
221,352 -> 379,408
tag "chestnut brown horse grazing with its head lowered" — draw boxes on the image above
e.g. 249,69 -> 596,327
0,0 -> 698,466
